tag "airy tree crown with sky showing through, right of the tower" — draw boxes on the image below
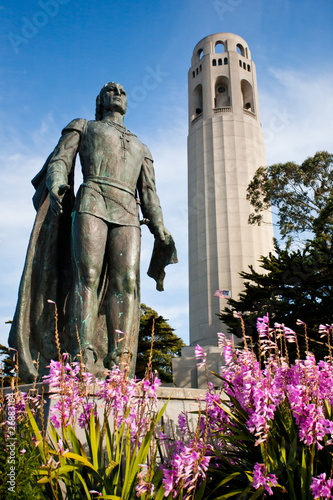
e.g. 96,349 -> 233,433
247,151 -> 333,242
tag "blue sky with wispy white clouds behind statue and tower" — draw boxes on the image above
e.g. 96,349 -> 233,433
0,0 -> 333,343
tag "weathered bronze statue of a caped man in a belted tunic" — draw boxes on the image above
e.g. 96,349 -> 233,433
9,83 -> 177,382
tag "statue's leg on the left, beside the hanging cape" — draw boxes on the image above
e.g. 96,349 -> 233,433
72,213 -> 108,369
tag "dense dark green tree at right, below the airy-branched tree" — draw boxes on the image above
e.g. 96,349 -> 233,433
220,241 -> 333,358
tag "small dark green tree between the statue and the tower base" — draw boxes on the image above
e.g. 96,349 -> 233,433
135,304 -> 185,382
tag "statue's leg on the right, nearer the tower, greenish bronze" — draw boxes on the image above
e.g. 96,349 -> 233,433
104,226 -> 141,375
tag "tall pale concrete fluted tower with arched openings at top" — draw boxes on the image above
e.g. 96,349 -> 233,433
188,33 -> 273,346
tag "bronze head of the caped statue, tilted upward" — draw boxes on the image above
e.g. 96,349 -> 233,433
96,82 -> 127,120
